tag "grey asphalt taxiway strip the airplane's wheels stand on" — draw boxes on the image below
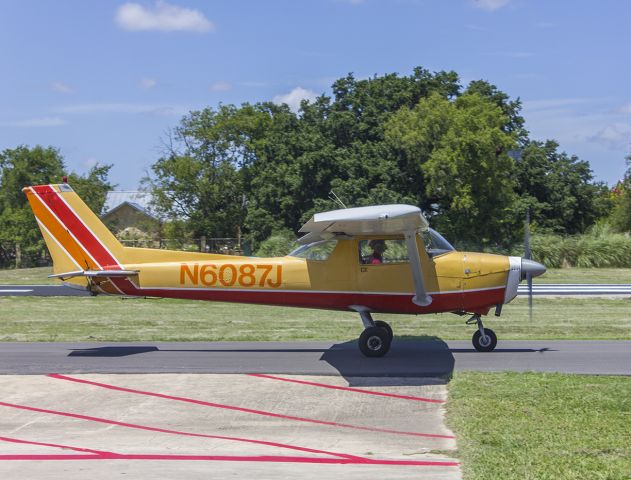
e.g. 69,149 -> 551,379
0,339 -> 631,384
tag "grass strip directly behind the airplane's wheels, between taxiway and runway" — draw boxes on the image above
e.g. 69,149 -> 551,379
0,297 -> 631,341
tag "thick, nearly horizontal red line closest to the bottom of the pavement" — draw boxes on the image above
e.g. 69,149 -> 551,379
0,453 -> 459,467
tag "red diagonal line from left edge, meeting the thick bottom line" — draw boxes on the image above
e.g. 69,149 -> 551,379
0,402 -> 362,459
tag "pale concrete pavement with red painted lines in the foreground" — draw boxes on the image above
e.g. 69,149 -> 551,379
0,374 -> 460,480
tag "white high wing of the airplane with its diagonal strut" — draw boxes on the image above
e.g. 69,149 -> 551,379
298,205 -> 432,306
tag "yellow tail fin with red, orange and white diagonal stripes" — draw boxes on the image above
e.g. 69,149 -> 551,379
23,183 -> 124,285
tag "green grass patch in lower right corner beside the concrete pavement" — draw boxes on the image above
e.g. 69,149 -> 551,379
447,372 -> 631,480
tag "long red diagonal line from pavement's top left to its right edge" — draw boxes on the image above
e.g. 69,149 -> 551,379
48,373 -> 455,439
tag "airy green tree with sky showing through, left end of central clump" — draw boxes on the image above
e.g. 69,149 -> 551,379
144,105 -> 265,237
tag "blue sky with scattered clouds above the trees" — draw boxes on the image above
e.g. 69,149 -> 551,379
0,0 -> 631,190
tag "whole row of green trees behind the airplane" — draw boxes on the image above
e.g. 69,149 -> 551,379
0,67 -> 631,261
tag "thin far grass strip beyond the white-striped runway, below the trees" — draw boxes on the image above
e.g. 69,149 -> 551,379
0,267 -> 631,285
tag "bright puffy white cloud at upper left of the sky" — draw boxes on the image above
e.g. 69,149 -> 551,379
115,0 -> 215,33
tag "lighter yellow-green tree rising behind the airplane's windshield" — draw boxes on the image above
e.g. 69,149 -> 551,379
386,93 -> 516,244
